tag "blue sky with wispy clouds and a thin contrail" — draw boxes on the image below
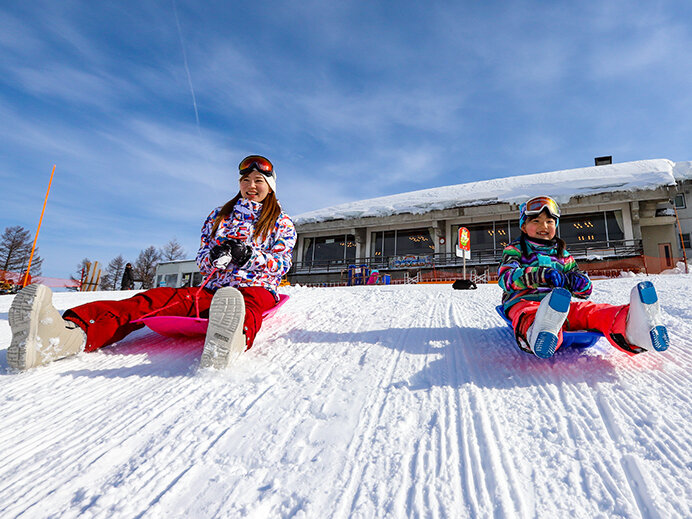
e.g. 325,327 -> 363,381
0,0 -> 692,277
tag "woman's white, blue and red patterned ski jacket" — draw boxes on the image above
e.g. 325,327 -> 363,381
197,198 -> 296,297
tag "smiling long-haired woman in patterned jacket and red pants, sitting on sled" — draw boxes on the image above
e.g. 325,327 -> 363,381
7,155 -> 296,370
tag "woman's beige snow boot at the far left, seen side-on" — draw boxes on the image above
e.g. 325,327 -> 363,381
7,284 -> 86,370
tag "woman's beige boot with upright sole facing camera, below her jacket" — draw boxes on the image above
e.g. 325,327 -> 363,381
199,287 -> 246,369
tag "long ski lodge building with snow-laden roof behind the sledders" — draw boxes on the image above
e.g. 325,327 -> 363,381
156,158 -> 692,286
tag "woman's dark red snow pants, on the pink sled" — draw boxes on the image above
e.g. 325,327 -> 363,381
63,287 -> 276,351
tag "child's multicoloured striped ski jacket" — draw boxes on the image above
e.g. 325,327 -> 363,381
497,235 -> 593,313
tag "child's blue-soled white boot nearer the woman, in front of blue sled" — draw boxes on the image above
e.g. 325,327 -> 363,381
526,288 -> 572,359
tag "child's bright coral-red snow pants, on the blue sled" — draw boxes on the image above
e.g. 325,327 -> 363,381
507,300 -> 637,355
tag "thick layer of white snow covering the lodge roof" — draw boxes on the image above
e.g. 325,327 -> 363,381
294,159 -> 680,224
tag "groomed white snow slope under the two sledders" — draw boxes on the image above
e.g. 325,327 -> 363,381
0,275 -> 692,518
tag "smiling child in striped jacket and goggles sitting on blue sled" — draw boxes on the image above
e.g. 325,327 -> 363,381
498,196 -> 670,359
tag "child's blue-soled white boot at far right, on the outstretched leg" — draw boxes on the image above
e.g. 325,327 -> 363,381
625,281 -> 670,351
